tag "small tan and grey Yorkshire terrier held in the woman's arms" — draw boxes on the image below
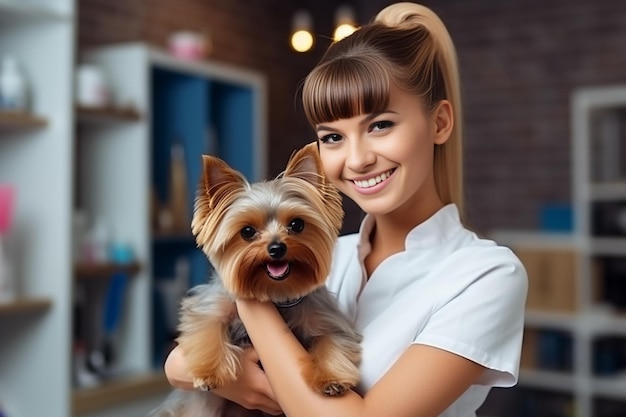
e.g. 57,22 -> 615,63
151,143 -> 361,417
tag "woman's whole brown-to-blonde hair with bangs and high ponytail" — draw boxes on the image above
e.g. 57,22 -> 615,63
302,2 -> 463,213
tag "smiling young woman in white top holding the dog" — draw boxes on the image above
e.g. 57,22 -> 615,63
166,3 -> 527,417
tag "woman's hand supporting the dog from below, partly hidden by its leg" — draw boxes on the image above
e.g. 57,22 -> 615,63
165,346 -> 282,415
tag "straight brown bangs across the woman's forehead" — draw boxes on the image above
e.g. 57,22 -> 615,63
302,56 -> 391,126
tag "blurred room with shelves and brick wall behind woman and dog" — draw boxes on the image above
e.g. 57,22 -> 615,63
0,0 -> 626,417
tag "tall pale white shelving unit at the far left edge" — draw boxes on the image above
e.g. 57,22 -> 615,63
0,0 -> 75,417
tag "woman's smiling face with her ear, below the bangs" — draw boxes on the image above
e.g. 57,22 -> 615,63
316,84 -> 452,220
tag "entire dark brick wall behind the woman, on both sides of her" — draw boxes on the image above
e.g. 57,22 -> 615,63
78,0 -> 626,231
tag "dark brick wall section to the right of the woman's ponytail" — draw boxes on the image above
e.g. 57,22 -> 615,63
361,0 -> 626,234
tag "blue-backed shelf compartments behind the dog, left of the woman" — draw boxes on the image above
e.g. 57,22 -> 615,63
151,61 -> 259,366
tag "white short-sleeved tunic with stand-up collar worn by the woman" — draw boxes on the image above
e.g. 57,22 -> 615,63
327,204 -> 527,417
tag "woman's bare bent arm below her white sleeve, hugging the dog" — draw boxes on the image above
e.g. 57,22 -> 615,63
237,300 -> 485,417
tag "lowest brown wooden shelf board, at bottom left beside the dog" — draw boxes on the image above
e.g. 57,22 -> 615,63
72,373 -> 171,415
